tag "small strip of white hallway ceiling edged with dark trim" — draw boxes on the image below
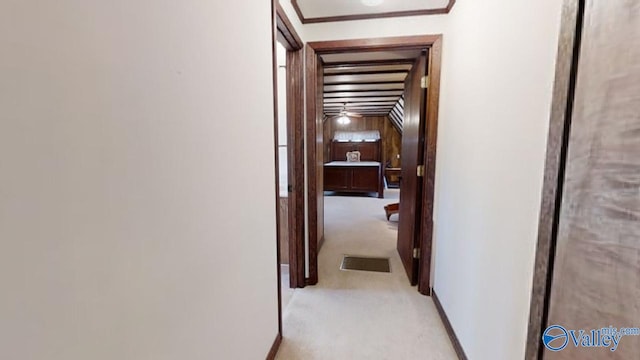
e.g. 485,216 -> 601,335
291,0 -> 455,23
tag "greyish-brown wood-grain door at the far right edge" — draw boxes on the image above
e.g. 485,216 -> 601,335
543,0 -> 640,359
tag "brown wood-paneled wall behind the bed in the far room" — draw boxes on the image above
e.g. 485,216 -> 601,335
324,116 -> 402,167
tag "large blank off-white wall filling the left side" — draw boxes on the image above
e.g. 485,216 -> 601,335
0,0 -> 277,360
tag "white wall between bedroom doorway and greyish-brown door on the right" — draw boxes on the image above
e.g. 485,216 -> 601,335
435,0 -> 561,360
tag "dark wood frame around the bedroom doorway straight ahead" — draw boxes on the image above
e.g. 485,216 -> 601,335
305,35 -> 442,295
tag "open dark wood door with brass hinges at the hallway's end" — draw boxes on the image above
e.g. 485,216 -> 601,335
397,55 -> 427,285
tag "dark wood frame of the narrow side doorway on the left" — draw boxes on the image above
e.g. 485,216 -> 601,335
268,0 -> 305,348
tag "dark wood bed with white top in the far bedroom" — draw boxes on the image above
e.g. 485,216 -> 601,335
324,133 -> 384,198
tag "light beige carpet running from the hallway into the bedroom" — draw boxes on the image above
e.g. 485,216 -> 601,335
277,190 -> 457,360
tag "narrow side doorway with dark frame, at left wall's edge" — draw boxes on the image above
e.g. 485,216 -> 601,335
270,2 -> 305,346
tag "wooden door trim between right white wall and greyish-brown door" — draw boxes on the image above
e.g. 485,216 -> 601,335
525,0 -> 584,360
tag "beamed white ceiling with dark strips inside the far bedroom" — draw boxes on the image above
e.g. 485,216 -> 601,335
321,50 -> 421,126
